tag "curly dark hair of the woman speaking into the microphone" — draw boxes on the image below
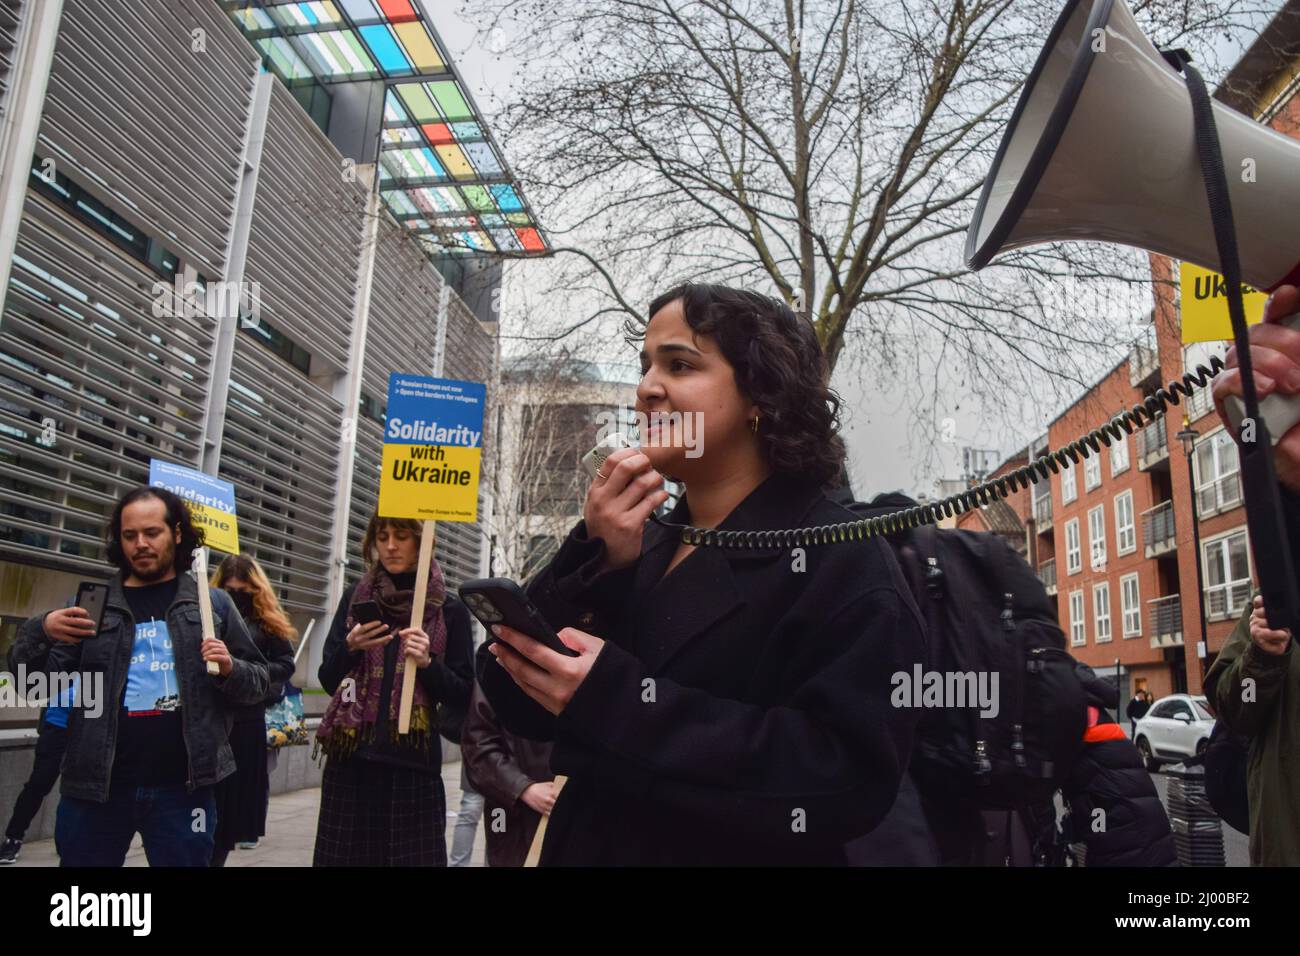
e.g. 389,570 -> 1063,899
624,282 -> 845,488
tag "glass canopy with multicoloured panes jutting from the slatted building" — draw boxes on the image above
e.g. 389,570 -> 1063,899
221,0 -> 549,255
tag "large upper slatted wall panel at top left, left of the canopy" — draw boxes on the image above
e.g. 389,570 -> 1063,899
36,0 -> 257,278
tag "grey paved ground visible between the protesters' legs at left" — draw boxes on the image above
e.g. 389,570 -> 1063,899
8,761 -> 485,869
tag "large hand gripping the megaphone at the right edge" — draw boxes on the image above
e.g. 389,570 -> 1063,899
1213,285 -> 1300,493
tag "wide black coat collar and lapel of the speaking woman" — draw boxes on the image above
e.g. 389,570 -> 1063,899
633,475 -> 820,674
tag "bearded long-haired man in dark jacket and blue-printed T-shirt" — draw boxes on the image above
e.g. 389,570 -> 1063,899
10,486 -> 268,866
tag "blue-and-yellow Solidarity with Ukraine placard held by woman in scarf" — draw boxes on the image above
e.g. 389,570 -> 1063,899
380,372 -> 488,522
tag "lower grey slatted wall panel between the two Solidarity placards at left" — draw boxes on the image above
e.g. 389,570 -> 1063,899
220,334 -> 343,615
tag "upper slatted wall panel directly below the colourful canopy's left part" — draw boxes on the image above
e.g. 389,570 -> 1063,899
243,82 -> 365,375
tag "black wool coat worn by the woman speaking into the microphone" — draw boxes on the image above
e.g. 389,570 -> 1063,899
478,475 -> 926,865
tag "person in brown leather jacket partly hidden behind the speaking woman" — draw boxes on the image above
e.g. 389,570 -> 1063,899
460,683 -> 558,866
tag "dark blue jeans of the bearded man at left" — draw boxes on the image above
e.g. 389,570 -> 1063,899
55,783 -> 217,866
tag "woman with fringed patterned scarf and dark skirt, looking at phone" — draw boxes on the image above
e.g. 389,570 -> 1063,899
312,515 -> 473,866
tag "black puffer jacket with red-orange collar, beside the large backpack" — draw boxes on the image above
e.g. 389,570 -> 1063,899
1063,663 -> 1178,866
